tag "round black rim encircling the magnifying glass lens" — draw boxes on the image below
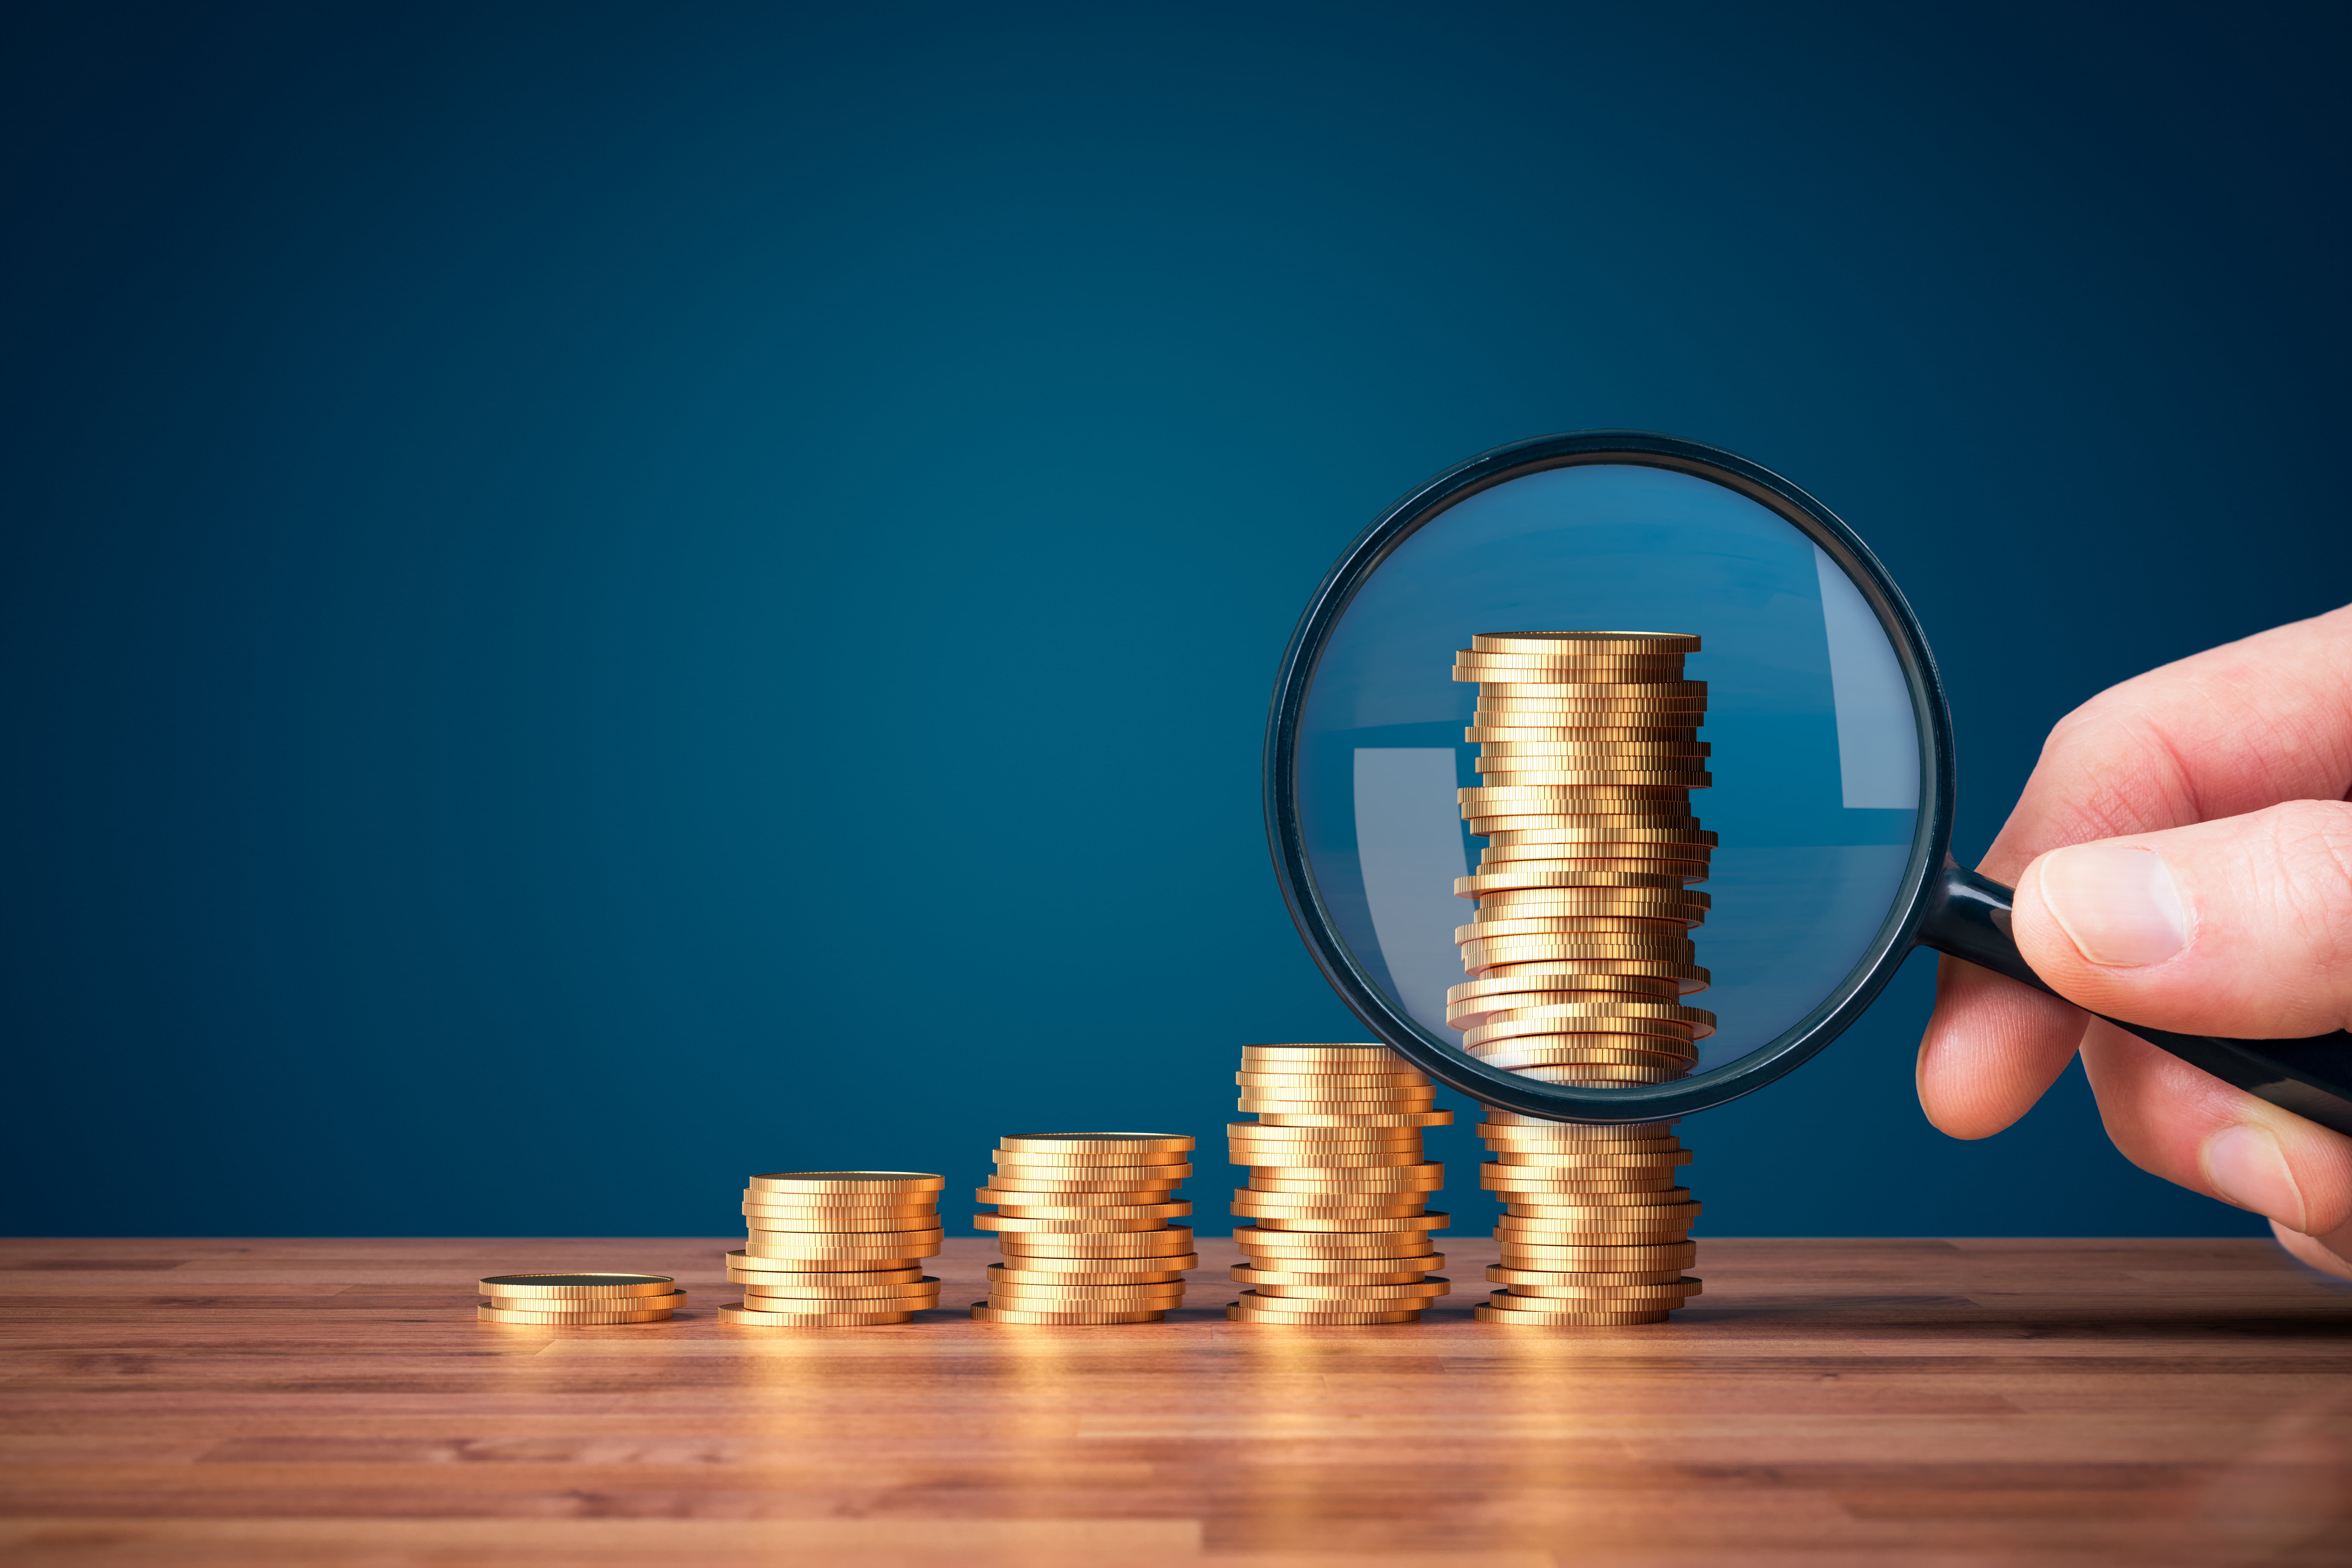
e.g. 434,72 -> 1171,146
1265,430 -> 1952,1124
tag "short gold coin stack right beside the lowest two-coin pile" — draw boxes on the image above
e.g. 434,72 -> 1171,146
720,1171 -> 948,1328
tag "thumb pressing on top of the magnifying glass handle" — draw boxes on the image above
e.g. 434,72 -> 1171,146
2013,799 -> 2352,1039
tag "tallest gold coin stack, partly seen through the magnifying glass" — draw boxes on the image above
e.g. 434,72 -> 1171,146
1447,632 -> 1715,1323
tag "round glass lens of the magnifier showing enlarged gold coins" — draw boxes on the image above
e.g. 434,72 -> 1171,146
1296,461 -> 1924,1084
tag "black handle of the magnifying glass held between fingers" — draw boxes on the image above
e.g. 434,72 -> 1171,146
1917,856 -> 2352,1133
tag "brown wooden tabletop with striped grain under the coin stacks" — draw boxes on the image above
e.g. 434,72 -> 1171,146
0,1239 -> 2352,1568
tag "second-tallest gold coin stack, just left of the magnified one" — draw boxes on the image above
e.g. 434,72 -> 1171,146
1225,1046 -> 1454,1323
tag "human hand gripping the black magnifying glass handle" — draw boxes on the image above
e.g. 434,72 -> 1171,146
1919,609 -> 2352,1279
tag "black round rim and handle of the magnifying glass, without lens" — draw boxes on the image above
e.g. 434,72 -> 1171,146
1265,430 -> 2352,1133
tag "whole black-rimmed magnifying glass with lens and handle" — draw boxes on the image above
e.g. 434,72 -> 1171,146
1265,430 -> 2352,1133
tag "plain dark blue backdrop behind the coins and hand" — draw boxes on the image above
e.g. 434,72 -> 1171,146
0,0 -> 2352,1234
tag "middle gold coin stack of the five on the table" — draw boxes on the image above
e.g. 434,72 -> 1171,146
971,1133 -> 1199,1323
